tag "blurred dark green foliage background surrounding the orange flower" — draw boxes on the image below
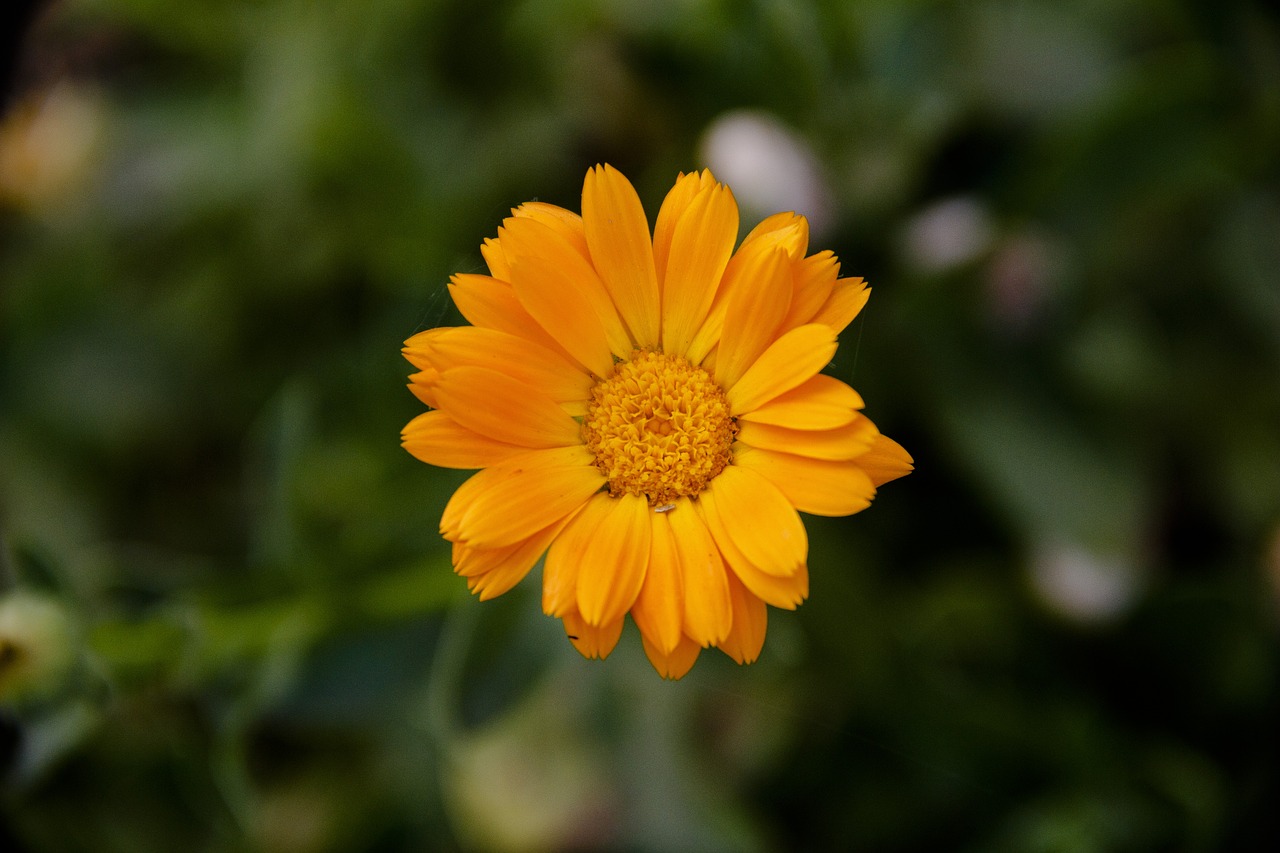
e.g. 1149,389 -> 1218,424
0,0 -> 1280,853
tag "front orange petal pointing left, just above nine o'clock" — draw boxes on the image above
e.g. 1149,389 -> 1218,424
435,366 -> 582,448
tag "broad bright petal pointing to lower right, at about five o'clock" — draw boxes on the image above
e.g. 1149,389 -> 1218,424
700,466 -> 809,578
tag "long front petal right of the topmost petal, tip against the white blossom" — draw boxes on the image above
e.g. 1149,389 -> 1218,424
662,184 -> 737,355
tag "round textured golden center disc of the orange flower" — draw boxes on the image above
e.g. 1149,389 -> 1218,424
582,350 -> 737,507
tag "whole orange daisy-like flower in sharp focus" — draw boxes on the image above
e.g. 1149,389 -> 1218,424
403,165 -> 911,679
